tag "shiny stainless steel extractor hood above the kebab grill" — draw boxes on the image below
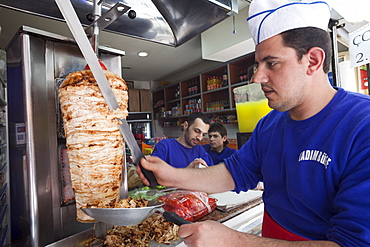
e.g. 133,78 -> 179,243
0,0 -> 237,47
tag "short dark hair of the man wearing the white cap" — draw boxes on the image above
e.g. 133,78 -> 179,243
281,27 -> 333,73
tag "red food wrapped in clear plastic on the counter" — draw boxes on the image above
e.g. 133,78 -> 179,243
158,191 -> 216,221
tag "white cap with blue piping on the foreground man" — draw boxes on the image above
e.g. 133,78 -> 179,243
247,0 -> 330,45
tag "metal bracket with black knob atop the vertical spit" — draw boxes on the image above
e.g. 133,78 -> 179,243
85,2 -> 131,37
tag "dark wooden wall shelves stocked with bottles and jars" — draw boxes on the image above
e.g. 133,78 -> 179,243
152,51 -> 254,127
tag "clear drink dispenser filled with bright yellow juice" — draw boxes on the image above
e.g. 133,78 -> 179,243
233,83 -> 271,147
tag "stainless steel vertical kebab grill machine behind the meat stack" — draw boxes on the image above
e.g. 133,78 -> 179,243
6,1 -> 133,246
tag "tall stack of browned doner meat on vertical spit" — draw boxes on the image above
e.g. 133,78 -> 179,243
59,70 -> 128,222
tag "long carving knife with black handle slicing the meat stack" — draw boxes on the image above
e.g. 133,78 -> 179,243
55,0 -> 158,187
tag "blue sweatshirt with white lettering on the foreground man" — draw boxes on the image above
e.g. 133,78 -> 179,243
225,88 -> 370,246
